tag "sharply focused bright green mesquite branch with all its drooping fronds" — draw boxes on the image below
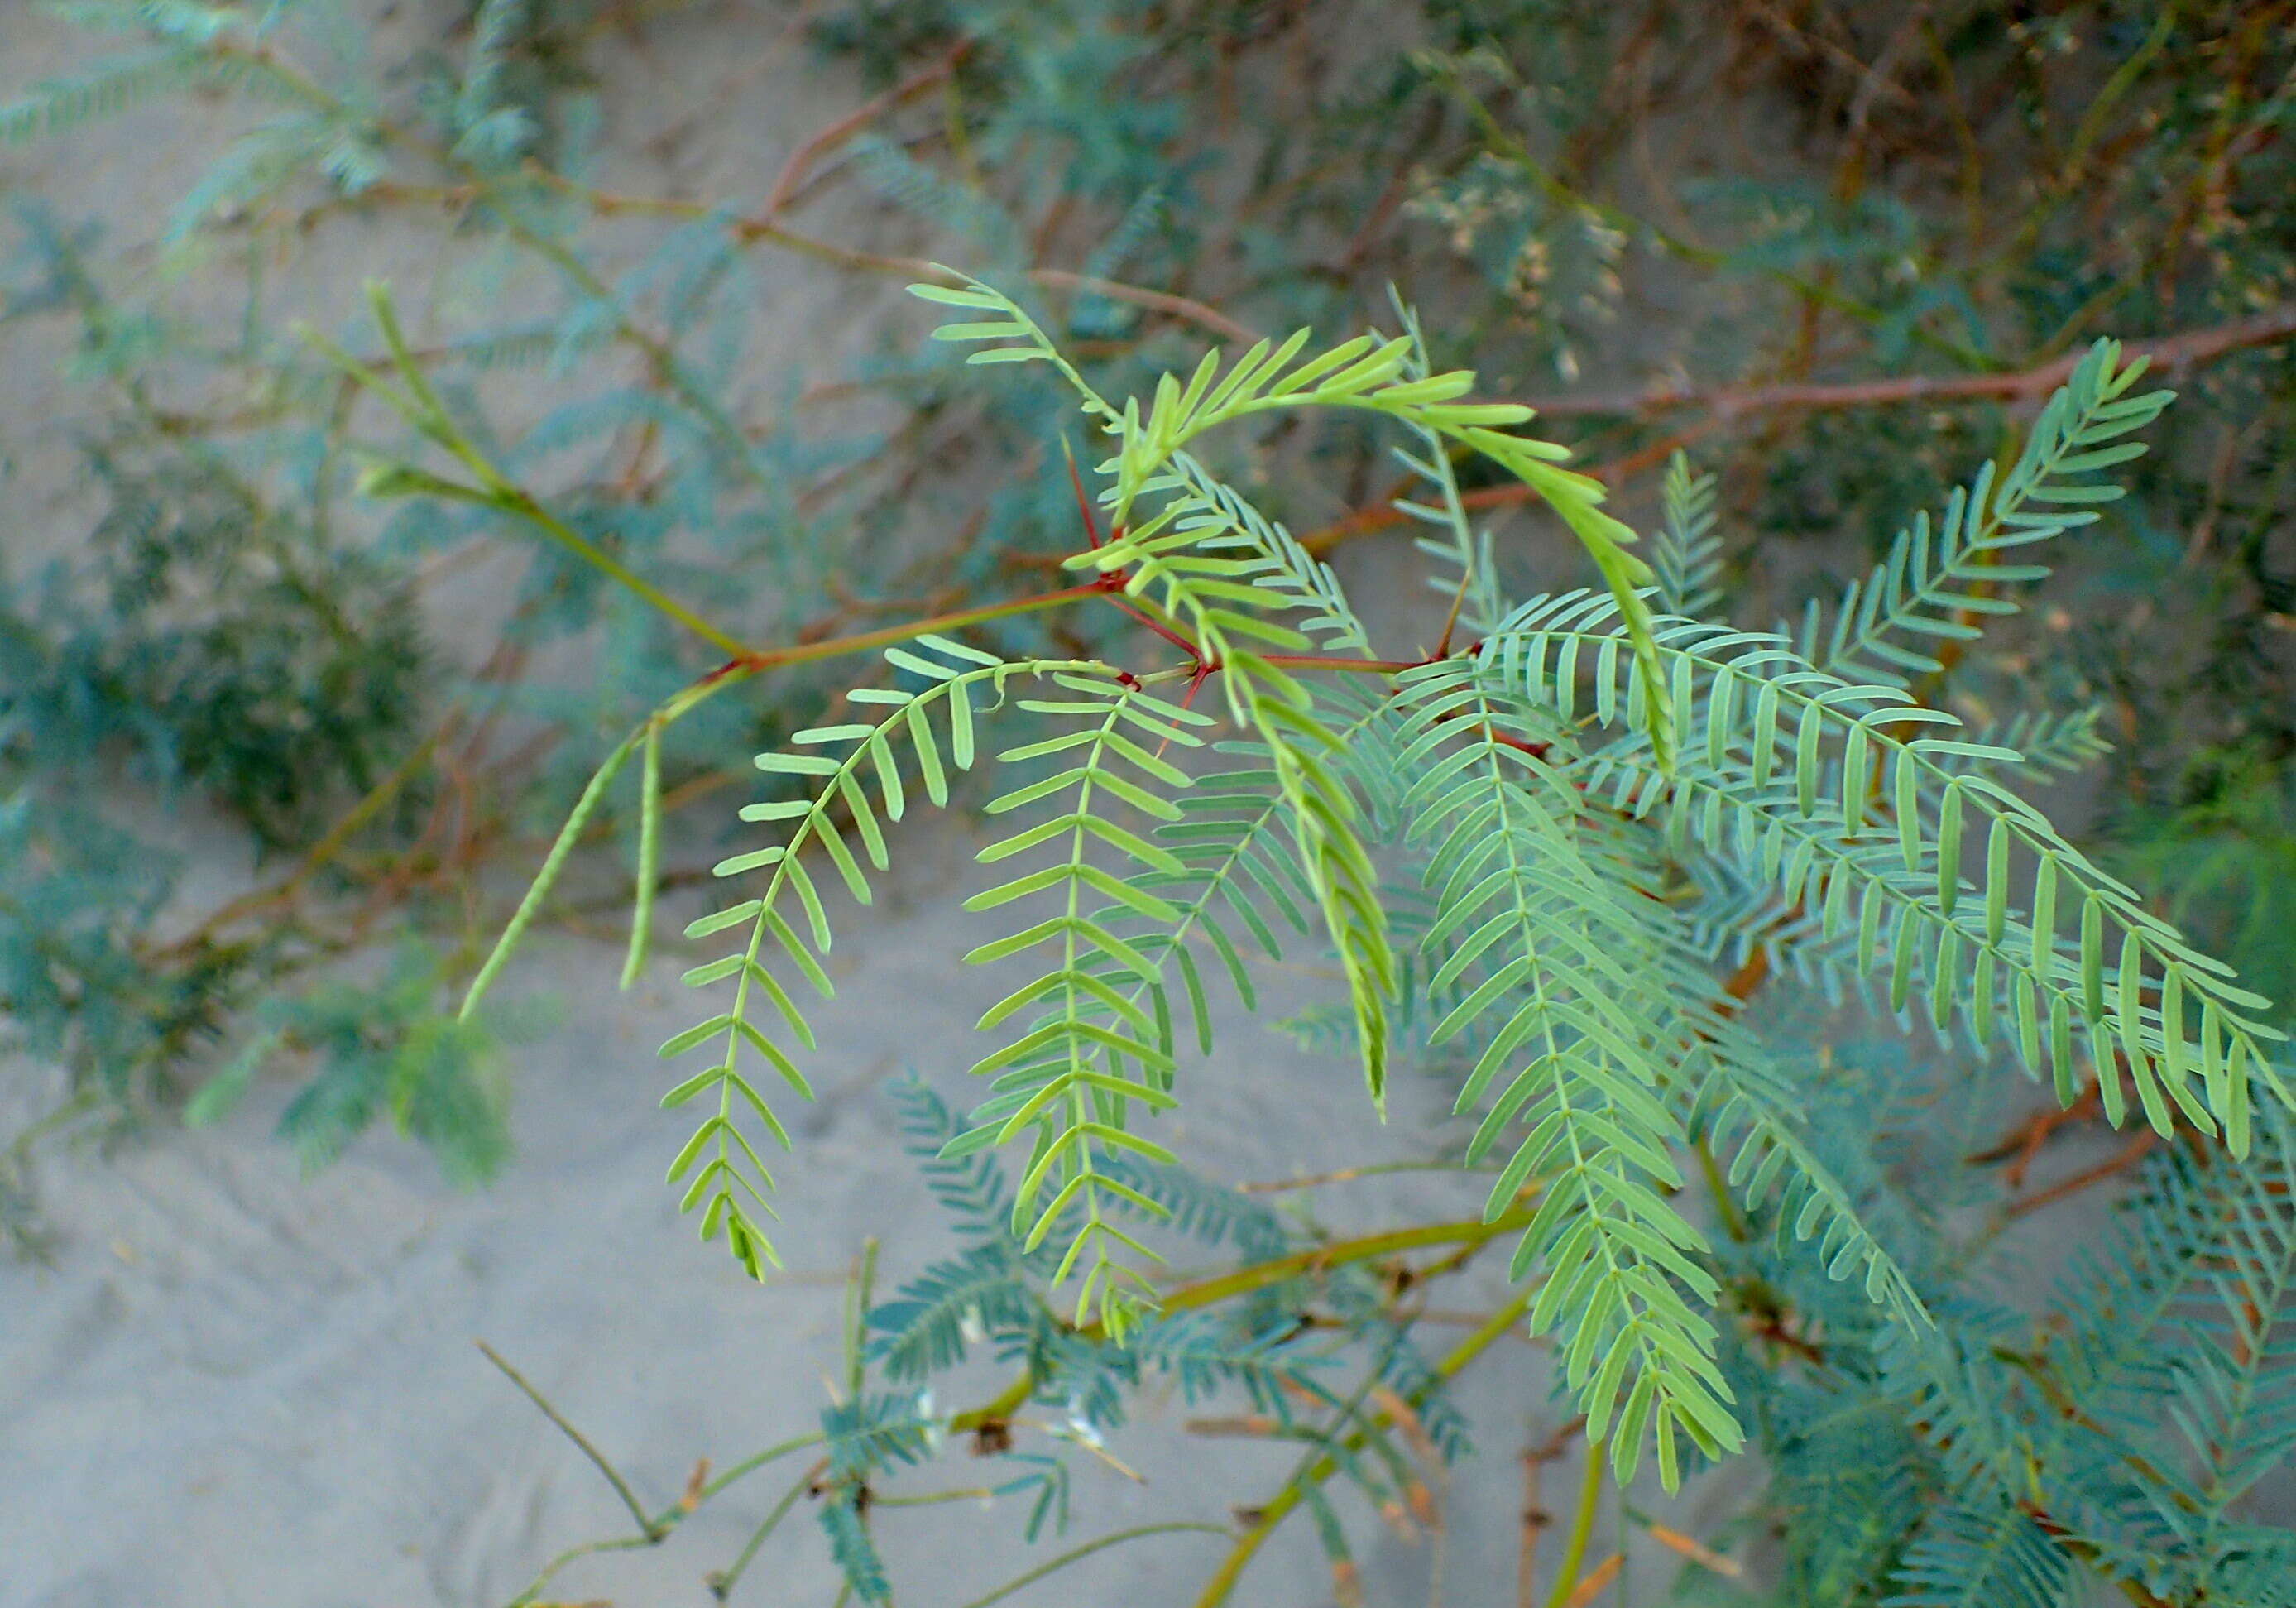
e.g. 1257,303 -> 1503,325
427,276 -> 2287,1515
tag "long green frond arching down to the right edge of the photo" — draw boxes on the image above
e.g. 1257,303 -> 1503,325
1481,595 -> 2284,1153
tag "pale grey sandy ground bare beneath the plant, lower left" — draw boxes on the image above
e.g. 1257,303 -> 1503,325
0,832 -> 1607,1608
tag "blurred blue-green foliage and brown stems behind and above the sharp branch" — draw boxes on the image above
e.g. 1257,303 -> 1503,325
0,0 -> 2296,1224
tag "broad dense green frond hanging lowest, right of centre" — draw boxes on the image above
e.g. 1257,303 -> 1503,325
1403,661 -> 1742,1486
